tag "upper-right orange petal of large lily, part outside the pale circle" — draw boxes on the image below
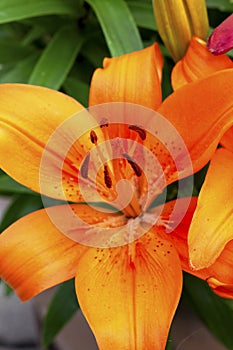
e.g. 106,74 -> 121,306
158,69 -> 233,172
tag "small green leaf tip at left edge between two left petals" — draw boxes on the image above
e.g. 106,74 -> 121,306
0,174 -> 37,195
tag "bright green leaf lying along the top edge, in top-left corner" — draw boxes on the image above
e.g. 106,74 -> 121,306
0,0 -> 82,23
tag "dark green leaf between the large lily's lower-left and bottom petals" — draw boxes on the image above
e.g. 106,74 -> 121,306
42,280 -> 79,347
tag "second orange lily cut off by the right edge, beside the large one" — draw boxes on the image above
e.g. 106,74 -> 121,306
172,34 -> 233,290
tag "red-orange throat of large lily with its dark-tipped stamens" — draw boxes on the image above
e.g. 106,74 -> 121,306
80,122 -> 151,218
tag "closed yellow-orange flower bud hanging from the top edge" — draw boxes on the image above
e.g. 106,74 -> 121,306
153,0 -> 209,61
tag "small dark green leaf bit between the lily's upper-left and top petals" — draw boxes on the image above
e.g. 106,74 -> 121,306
63,78 -> 90,107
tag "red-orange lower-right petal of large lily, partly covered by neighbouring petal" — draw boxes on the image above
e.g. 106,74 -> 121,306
160,197 -> 233,298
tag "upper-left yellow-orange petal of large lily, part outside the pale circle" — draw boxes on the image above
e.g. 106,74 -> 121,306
0,84 -> 83,196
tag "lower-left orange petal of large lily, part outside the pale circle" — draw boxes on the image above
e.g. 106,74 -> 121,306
0,210 -> 82,300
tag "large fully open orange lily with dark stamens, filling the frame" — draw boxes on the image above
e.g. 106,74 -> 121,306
0,44 -> 233,350
